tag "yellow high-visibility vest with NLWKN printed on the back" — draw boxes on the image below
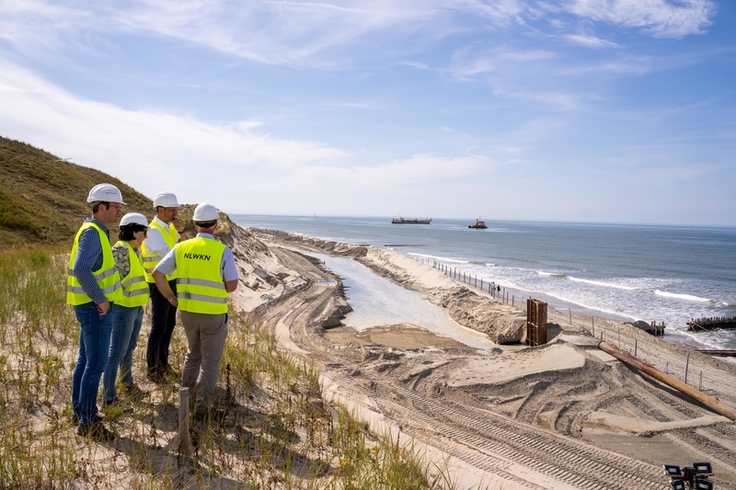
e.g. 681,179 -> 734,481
174,237 -> 227,315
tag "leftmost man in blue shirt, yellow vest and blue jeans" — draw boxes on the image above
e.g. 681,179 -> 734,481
66,184 -> 125,441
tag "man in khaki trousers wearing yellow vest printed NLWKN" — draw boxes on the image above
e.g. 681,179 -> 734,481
153,202 -> 238,420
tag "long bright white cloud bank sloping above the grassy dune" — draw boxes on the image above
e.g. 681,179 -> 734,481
0,61 -> 500,211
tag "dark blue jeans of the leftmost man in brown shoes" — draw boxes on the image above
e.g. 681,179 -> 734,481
72,302 -> 112,425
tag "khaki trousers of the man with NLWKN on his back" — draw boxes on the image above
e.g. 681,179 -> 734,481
180,310 -> 227,409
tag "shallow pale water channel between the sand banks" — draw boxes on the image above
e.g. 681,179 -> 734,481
309,253 -> 495,350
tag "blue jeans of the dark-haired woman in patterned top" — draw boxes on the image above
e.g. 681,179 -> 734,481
102,304 -> 143,401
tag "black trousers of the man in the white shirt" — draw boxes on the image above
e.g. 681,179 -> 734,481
146,280 -> 176,373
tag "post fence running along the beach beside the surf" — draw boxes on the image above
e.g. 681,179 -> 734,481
415,258 -> 732,390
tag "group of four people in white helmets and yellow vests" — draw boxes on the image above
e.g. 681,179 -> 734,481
67,184 -> 238,440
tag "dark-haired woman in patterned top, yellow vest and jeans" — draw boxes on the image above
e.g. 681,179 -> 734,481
102,213 -> 149,406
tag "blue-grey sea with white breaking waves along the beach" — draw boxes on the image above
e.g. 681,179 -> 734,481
232,215 -> 736,349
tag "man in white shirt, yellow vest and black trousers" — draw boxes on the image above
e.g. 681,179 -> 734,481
141,192 -> 186,383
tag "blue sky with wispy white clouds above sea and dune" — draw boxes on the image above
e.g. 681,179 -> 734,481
0,0 -> 736,226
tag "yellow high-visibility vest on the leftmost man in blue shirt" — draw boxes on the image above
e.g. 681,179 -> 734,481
66,221 -> 123,306
